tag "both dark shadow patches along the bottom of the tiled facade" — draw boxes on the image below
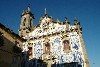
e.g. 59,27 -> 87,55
21,52 -> 82,67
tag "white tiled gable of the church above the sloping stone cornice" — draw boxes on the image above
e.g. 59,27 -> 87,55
29,16 -> 69,38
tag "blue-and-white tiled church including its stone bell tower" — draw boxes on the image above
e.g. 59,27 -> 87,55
19,6 -> 90,67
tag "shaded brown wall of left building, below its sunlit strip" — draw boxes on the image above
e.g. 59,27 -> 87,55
0,34 -> 21,67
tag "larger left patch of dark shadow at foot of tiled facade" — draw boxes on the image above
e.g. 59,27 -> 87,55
21,52 -> 47,67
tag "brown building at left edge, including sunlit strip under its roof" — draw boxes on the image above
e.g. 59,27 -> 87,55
0,24 -> 22,67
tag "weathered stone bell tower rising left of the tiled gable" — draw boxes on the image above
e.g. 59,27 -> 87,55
19,6 -> 34,37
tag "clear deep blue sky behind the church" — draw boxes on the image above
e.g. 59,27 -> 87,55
0,0 -> 100,67
